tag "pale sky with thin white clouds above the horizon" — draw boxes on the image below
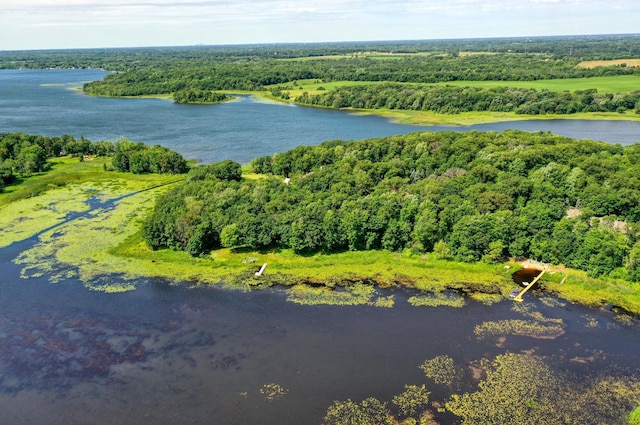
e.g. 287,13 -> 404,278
0,0 -> 640,50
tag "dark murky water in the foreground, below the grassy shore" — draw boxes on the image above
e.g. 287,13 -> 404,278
0,234 -> 640,424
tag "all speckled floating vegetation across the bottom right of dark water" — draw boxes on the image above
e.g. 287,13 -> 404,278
323,353 -> 640,425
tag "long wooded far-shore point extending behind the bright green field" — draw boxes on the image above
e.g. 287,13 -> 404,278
84,53 -> 640,96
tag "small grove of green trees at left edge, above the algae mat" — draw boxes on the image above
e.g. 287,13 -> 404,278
0,133 -> 188,191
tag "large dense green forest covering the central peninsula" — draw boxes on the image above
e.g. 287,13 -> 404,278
143,131 -> 640,280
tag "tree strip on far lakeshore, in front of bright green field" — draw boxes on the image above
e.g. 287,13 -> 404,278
292,84 -> 640,115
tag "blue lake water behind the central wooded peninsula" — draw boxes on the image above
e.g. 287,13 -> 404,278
0,70 -> 640,163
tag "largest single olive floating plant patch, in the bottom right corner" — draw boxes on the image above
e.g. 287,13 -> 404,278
446,353 -> 640,425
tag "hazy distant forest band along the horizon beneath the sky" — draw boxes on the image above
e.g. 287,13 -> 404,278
0,34 -> 640,72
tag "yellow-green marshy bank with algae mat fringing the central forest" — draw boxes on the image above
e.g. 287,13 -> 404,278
0,159 -> 640,313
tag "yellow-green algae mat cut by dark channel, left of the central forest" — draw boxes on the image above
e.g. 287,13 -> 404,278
0,180 -> 172,292
